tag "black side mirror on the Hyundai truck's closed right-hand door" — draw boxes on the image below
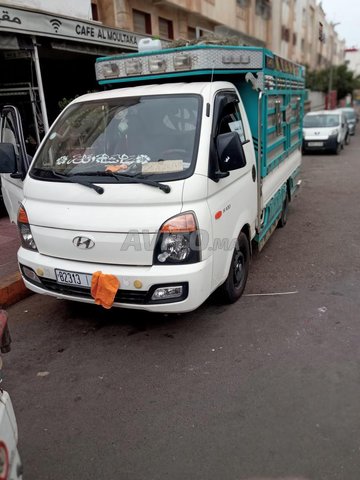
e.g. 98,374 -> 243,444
216,132 -> 246,172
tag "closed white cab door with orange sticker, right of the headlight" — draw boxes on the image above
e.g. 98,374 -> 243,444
208,91 -> 257,284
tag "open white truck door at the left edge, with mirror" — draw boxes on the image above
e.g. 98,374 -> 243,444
0,105 -> 31,223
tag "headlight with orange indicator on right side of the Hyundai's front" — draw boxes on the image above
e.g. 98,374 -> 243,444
154,213 -> 200,265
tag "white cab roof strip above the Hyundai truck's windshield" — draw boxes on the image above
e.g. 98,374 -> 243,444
74,82 -> 234,102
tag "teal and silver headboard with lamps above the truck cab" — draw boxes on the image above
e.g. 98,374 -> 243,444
95,45 -> 305,88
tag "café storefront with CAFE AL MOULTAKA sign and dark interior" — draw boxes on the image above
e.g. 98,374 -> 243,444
0,4 -> 149,154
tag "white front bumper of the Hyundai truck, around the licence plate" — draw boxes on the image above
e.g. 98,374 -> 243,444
18,247 -> 212,313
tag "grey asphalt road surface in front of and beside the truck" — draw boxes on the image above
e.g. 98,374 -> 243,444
5,134 -> 360,480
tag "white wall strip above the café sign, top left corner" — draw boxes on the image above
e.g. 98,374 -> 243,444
0,0 -> 92,20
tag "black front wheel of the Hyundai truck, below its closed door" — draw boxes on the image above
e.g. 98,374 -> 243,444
219,233 -> 250,303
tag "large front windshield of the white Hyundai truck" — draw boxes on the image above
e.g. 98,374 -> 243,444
30,95 -> 202,183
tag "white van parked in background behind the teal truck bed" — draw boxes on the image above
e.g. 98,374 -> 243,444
302,110 -> 348,154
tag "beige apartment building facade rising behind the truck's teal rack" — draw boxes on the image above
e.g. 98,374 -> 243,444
93,0 -> 345,70
